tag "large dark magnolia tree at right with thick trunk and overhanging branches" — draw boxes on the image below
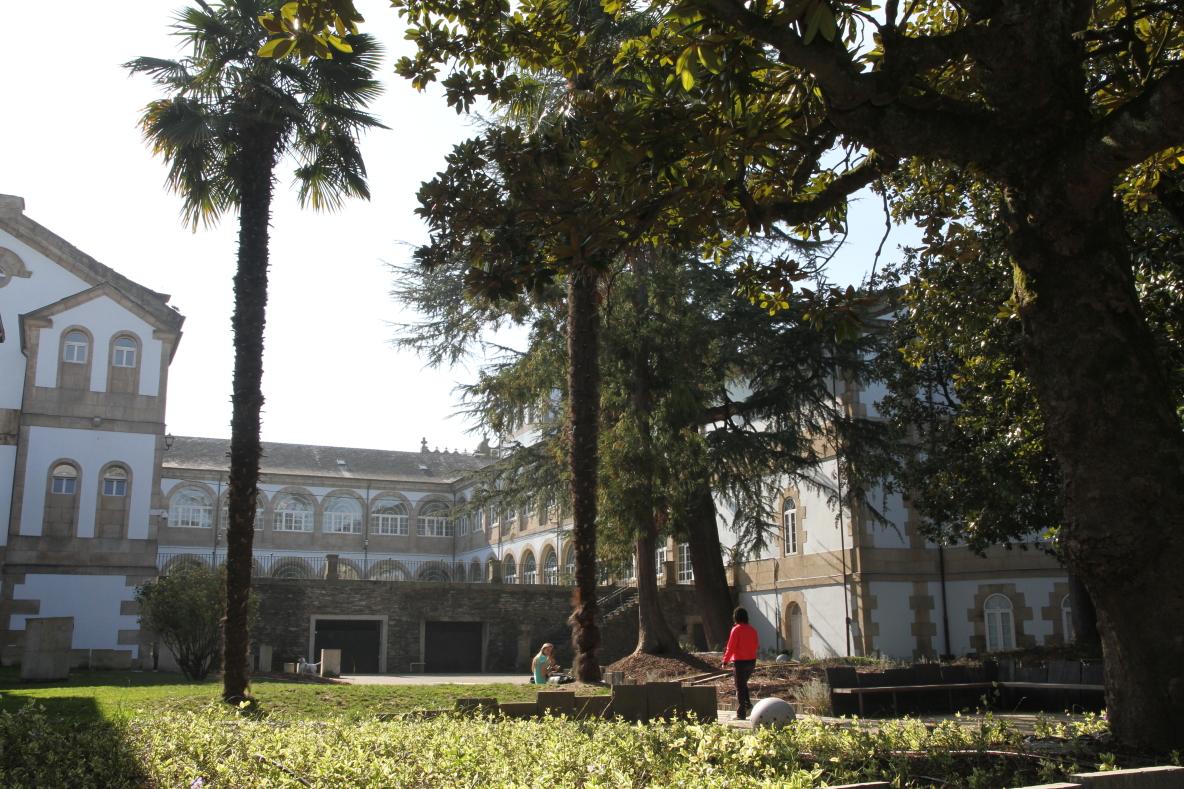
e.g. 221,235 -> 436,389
266,0 -> 1184,748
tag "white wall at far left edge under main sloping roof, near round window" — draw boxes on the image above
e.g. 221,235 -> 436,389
0,230 -> 88,409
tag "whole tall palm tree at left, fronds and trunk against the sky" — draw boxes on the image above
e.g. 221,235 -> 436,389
126,0 -> 381,701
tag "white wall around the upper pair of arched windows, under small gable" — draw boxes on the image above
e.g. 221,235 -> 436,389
32,294 -> 163,397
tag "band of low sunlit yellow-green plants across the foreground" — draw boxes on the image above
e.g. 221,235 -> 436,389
0,704 -> 1117,789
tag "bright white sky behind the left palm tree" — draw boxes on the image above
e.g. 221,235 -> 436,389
0,0 -> 908,450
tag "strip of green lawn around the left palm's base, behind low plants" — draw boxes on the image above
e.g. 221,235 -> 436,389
0,668 -> 558,721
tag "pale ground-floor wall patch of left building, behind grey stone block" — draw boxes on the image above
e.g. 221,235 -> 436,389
8,573 -> 140,658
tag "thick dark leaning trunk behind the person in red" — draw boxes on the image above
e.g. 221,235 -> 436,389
687,480 -> 733,649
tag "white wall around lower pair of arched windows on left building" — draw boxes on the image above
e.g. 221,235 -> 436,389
20,426 -> 156,539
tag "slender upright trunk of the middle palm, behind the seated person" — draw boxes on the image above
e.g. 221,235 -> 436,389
567,268 -> 600,682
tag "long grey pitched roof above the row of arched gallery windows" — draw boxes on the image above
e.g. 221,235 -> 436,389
162,436 -> 491,483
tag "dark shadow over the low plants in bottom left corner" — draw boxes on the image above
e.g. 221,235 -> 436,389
0,693 -> 152,789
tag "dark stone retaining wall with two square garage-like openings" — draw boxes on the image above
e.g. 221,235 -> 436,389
252,578 -> 697,673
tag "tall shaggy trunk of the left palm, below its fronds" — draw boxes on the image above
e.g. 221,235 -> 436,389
223,129 -> 275,704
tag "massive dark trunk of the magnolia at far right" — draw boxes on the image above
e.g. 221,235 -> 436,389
1010,187 -> 1184,751
